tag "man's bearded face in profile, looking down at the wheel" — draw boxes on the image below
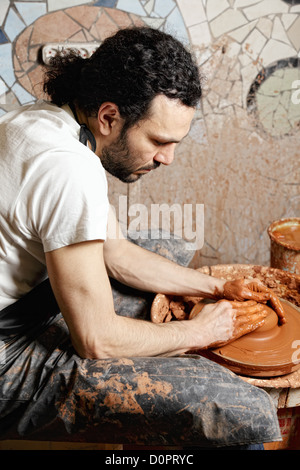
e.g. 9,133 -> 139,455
101,95 -> 195,183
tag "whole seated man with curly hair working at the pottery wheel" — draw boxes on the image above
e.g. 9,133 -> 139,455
0,27 -> 283,445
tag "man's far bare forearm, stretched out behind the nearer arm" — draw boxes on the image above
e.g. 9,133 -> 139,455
104,240 -> 225,297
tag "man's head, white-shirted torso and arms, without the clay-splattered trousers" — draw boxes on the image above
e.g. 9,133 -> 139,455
0,28 -> 280,448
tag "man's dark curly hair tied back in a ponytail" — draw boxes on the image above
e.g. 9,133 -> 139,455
44,27 -> 201,127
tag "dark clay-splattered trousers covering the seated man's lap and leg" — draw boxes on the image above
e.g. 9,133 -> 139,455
0,280 -> 281,447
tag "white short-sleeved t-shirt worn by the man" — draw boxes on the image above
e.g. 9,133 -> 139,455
0,101 -> 109,310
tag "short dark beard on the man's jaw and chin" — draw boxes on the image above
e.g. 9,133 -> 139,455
101,132 -> 160,183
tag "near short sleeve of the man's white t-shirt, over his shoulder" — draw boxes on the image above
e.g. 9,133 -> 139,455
16,151 -> 109,252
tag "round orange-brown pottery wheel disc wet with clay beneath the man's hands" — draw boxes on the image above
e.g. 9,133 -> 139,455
193,299 -> 300,377
